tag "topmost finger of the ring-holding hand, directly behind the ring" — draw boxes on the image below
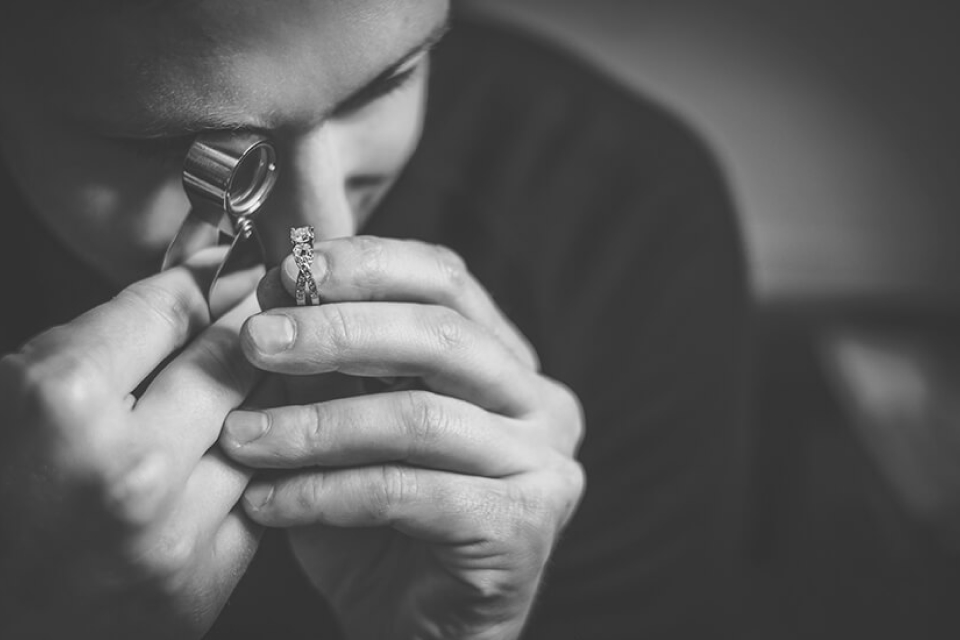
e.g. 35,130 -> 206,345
264,236 -> 537,369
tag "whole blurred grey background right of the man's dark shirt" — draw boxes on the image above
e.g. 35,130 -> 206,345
474,0 -> 960,638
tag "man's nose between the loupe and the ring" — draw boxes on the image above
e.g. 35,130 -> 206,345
257,126 -> 356,267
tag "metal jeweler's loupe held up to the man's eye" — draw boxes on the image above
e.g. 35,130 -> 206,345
163,131 -> 277,315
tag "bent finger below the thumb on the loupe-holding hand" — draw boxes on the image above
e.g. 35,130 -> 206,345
133,295 -> 258,481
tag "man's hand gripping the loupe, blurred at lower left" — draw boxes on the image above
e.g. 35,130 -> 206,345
0,258 -> 259,639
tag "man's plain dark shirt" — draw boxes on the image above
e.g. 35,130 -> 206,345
0,12 -> 747,640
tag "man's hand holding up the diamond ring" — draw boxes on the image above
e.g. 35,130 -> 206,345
221,237 -> 583,640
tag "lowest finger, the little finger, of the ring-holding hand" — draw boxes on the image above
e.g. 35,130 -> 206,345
243,457 -> 583,545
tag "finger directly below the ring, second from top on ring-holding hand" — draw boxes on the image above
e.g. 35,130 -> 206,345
241,302 -> 538,415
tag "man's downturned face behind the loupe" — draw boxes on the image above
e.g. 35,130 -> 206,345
0,0 -> 449,284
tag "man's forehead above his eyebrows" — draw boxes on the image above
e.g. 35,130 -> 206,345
15,0 -> 449,135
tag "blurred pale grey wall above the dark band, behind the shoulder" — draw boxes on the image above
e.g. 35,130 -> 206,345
474,0 -> 960,302
